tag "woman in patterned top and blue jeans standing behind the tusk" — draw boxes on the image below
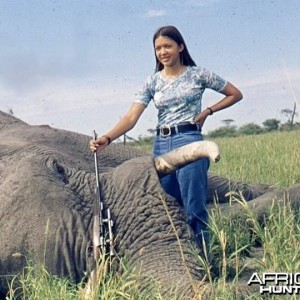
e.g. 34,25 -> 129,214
90,26 -> 242,245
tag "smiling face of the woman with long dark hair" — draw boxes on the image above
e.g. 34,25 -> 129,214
154,36 -> 184,67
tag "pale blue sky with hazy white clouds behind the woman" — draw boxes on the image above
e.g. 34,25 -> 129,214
0,0 -> 300,138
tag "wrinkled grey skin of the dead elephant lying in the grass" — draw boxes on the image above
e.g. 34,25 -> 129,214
0,112 -> 300,299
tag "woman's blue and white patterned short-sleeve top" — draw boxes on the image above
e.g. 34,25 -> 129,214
134,66 -> 227,126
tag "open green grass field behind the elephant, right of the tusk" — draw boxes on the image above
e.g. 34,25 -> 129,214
211,130 -> 300,187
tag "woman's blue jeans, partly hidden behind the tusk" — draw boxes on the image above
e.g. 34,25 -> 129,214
153,131 -> 209,245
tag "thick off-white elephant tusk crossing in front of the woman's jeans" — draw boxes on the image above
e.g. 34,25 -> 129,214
154,141 -> 221,174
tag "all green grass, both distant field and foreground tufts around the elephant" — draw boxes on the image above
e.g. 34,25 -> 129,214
7,131 -> 300,300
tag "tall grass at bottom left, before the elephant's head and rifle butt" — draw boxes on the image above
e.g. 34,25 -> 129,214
6,258 -> 168,300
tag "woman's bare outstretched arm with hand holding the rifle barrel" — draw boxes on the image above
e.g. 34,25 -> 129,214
89,103 -> 146,151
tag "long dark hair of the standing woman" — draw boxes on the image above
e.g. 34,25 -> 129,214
153,26 -> 196,72
